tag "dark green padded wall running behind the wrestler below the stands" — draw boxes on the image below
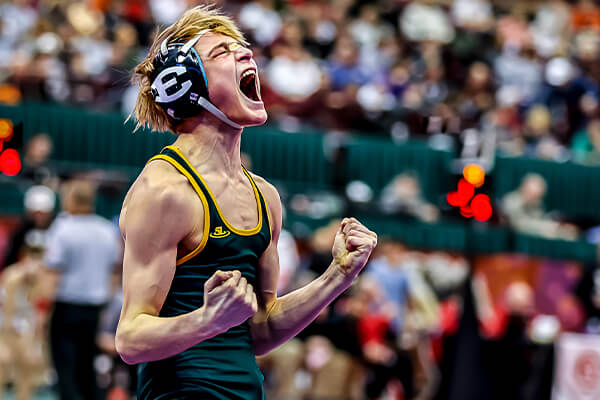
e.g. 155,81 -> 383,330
0,103 -> 600,261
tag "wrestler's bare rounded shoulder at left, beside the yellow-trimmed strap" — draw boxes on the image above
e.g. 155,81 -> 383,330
119,160 -> 196,238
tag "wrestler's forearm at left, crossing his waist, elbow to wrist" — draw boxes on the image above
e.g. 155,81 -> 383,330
115,309 -> 219,364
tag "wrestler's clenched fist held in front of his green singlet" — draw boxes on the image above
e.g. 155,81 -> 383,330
202,270 -> 258,334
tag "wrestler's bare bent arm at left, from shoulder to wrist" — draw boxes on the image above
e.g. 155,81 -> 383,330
115,166 -> 247,364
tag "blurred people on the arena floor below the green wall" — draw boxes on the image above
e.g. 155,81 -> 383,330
0,176 -> 600,400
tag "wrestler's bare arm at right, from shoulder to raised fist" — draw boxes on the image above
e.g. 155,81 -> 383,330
250,180 -> 376,355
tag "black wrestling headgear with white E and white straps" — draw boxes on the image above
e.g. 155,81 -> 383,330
150,29 -> 243,129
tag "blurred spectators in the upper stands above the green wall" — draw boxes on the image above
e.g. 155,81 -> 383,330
0,0 -> 600,165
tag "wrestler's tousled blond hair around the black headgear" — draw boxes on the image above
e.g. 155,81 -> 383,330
127,5 -> 247,133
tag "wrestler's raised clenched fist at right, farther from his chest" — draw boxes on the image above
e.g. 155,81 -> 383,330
331,218 -> 377,279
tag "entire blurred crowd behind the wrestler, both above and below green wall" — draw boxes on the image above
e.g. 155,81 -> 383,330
5,0 -> 600,400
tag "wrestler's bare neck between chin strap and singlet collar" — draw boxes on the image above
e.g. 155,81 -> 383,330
174,117 -> 242,176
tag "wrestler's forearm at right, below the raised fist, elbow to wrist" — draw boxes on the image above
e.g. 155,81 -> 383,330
252,263 -> 353,355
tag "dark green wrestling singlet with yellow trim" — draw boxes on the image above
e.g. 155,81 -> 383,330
137,146 -> 271,400
